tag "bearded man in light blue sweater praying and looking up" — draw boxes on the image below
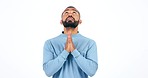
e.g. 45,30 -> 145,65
43,6 -> 98,78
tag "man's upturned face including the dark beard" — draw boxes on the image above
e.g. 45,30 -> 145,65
62,8 -> 80,28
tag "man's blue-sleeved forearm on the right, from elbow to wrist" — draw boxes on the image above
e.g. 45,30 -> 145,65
72,49 -> 98,76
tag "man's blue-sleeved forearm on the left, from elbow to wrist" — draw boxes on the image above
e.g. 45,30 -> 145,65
43,50 -> 69,77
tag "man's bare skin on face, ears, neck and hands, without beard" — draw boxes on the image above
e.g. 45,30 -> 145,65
60,8 -> 82,52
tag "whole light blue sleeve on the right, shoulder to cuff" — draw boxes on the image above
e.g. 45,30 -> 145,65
71,42 -> 98,76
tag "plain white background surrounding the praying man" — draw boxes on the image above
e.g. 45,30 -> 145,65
0,0 -> 148,78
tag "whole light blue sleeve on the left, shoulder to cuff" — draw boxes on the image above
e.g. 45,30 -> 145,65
43,41 -> 69,77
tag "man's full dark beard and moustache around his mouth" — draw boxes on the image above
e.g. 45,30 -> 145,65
62,16 -> 79,28
